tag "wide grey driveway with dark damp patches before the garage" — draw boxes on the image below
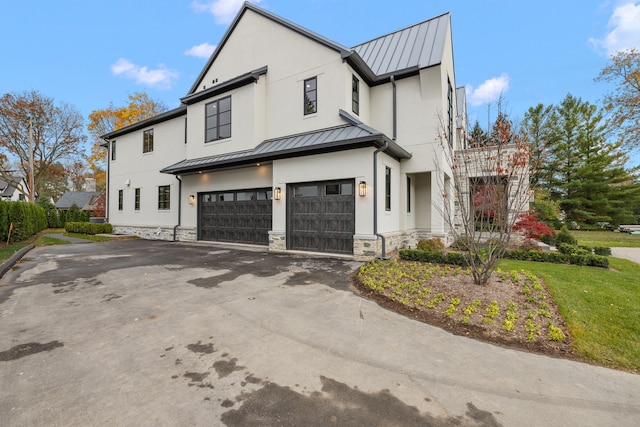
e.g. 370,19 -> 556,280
0,240 -> 640,426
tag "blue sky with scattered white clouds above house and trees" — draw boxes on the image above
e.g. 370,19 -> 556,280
0,0 -> 640,163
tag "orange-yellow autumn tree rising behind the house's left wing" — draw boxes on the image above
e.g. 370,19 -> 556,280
87,92 -> 167,176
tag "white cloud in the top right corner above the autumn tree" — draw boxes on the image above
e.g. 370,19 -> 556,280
589,0 -> 640,55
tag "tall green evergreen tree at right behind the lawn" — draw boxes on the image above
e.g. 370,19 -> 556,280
530,94 -> 640,226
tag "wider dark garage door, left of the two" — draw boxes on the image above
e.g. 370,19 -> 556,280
198,188 -> 272,245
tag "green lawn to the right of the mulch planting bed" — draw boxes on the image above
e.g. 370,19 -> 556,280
500,256 -> 640,372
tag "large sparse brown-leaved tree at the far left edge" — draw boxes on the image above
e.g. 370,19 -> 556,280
0,91 -> 86,201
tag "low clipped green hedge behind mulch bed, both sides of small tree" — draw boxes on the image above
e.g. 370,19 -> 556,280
400,249 -> 609,268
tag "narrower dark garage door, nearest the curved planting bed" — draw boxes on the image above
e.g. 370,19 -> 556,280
287,180 -> 355,254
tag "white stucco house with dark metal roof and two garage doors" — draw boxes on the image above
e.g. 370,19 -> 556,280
104,3 -> 466,259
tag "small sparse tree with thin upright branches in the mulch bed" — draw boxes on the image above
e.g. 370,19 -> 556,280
436,108 -> 530,285
